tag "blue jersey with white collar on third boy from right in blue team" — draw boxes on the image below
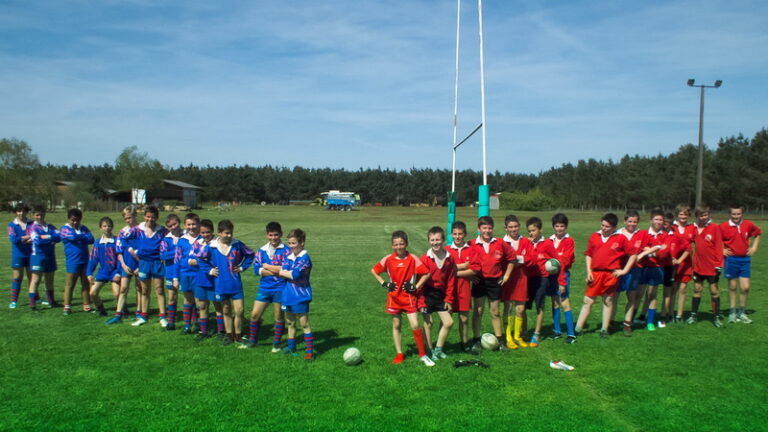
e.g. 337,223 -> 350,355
200,239 -> 255,294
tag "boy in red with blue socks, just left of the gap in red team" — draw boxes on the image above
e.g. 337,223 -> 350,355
549,213 -> 576,344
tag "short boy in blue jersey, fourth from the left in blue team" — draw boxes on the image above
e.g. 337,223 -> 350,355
86,217 -> 120,316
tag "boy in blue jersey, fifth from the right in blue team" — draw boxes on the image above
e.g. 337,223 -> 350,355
175,213 -> 202,334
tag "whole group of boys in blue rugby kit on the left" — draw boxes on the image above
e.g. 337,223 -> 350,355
8,205 -> 314,360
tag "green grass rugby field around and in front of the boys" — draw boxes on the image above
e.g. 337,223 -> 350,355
0,206 -> 768,431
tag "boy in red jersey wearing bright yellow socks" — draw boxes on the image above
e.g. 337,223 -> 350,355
501,215 -> 536,349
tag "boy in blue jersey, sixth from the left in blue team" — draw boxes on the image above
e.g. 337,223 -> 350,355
126,206 -> 168,327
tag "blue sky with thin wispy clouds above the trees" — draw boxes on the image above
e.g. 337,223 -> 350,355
0,0 -> 768,173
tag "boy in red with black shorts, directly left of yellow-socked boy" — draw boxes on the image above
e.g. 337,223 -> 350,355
469,216 -> 517,353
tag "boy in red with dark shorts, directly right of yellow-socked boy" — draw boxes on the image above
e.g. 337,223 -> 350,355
525,217 -> 558,347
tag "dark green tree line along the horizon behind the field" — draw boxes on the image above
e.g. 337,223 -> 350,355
0,129 -> 768,210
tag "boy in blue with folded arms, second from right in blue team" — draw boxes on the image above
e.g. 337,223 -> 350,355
248,222 -> 291,353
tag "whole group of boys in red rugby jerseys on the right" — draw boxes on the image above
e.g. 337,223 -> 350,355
371,205 -> 761,366
